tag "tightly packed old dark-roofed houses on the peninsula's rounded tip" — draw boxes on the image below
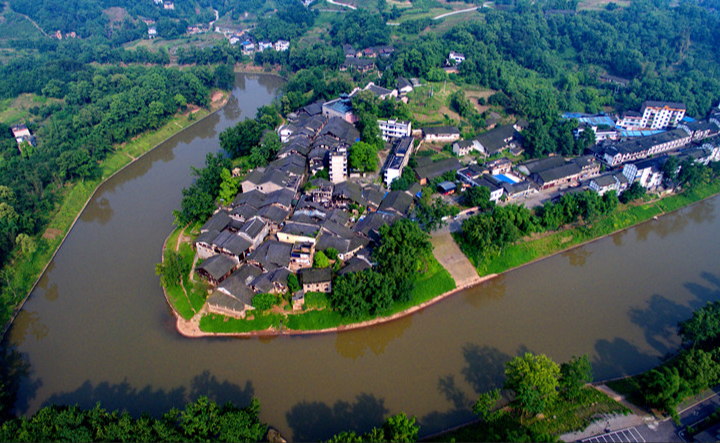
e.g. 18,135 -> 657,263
194,88 -> 428,317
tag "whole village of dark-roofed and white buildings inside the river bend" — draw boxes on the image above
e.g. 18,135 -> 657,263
184,71 -> 720,324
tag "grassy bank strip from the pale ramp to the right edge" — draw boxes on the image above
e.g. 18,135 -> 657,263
462,181 -> 720,275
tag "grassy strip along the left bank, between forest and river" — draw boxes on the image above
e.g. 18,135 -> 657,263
2,91 -> 231,337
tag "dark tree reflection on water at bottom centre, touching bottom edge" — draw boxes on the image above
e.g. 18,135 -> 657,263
286,393 -> 390,441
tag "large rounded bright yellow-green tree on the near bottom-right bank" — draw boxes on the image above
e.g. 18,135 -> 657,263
504,352 -> 560,416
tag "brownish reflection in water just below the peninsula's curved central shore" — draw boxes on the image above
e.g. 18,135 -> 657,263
335,316 -> 412,360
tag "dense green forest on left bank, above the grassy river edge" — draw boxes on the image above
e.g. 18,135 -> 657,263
0,59 -> 234,326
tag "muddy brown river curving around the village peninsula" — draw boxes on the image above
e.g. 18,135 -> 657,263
9,75 -> 720,441
